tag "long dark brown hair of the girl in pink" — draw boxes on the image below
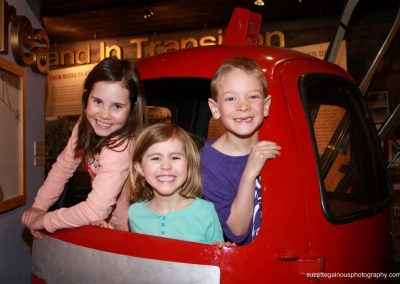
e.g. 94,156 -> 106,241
75,57 -> 147,158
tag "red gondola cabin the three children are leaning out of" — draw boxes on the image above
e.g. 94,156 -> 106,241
32,8 -> 390,283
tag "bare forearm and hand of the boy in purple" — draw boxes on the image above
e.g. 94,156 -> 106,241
227,141 -> 281,236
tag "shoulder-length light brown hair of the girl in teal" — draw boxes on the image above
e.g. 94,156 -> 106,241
130,122 -> 202,203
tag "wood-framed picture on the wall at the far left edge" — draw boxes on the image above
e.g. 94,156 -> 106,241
0,58 -> 26,213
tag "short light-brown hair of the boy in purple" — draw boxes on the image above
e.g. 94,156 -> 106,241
211,56 -> 267,101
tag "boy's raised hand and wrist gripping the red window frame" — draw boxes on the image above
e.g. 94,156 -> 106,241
245,141 -> 281,178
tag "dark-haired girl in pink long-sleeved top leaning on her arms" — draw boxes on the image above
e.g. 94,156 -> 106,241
22,57 -> 147,238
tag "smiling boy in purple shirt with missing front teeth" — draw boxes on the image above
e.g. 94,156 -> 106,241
201,57 -> 281,244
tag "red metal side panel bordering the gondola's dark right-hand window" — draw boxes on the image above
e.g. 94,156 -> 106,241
280,58 -> 390,283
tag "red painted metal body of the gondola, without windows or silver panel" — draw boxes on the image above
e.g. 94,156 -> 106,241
33,9 -> 390,283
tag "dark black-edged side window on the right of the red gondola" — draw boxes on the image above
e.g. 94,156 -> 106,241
300,74 -> 390,222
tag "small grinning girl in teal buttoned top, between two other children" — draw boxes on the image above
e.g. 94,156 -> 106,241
128,123 -> 225,244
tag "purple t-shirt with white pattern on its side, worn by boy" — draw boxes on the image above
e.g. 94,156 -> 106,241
200,141 -> 261,244
